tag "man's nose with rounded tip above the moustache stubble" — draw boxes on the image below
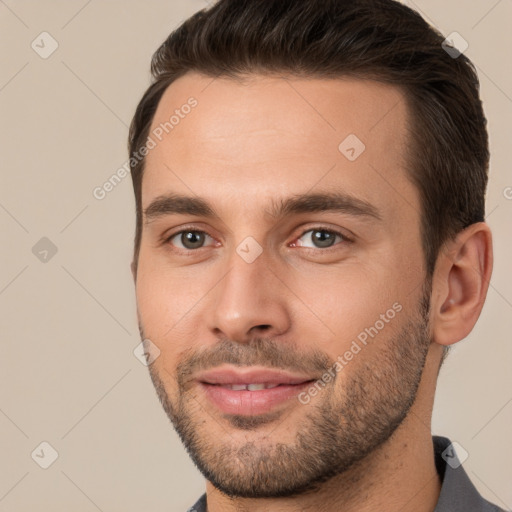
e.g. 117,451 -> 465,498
207,245 -> 290,343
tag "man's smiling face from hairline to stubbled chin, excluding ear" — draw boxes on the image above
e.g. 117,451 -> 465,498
136,73 -> 431,497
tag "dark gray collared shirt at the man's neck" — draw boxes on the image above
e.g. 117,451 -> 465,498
187,436 -> 505,512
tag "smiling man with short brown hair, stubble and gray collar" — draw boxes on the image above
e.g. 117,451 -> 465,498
129,0 -> 502,512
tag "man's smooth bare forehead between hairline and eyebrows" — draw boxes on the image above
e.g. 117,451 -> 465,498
142,72 -> 419,223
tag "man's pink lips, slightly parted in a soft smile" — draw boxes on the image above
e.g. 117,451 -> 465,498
196,367 -> 315,416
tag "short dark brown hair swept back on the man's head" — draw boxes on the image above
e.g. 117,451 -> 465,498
129,0 -> 489,280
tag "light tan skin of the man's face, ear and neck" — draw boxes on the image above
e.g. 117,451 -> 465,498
132,73 -> 492,512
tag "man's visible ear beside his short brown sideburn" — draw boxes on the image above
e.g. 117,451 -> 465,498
431,222 -> 493,345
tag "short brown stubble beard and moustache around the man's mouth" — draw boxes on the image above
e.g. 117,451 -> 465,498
141,294 -> 431,498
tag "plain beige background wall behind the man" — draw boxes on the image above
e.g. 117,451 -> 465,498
0,0 -> 512,512
